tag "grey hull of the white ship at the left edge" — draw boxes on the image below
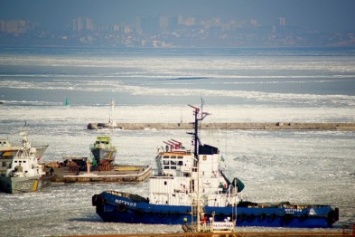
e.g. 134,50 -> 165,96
0,176 -> 51,194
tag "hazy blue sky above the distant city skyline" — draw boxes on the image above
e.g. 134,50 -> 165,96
0,0 -> 355,31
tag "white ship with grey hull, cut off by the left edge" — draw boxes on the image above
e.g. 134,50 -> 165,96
0,131 -> 50,193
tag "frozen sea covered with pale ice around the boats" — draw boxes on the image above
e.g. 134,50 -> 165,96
0,48 -> 355,236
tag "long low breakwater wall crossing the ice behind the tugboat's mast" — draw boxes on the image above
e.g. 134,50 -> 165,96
87,122 -> 355,131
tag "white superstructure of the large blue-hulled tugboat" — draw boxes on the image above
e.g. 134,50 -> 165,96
149,142 -> 240,207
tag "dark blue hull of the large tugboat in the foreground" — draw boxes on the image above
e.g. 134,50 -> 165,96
92,191 -> 339,228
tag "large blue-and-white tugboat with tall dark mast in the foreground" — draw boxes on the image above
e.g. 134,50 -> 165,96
92,103 -> 339,228
